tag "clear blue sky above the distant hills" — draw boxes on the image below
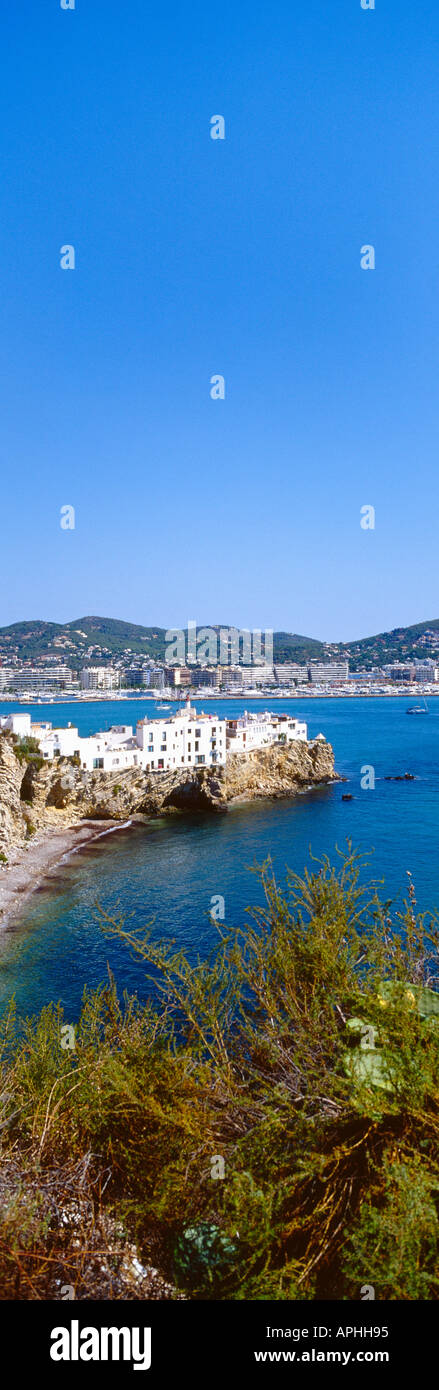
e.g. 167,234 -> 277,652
0,0 -> 439,641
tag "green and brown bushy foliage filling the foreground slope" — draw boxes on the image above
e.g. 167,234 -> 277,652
0,855 -> 439,1300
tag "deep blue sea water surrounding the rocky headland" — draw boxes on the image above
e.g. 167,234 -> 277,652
0,696 -> 439,1020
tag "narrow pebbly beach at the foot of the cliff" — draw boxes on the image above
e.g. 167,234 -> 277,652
0,820 -> 122,929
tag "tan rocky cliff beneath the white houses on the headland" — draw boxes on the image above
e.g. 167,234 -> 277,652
0,734 -> 336,858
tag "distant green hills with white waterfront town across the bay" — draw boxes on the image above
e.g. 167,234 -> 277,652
0,617 -> 439,703
